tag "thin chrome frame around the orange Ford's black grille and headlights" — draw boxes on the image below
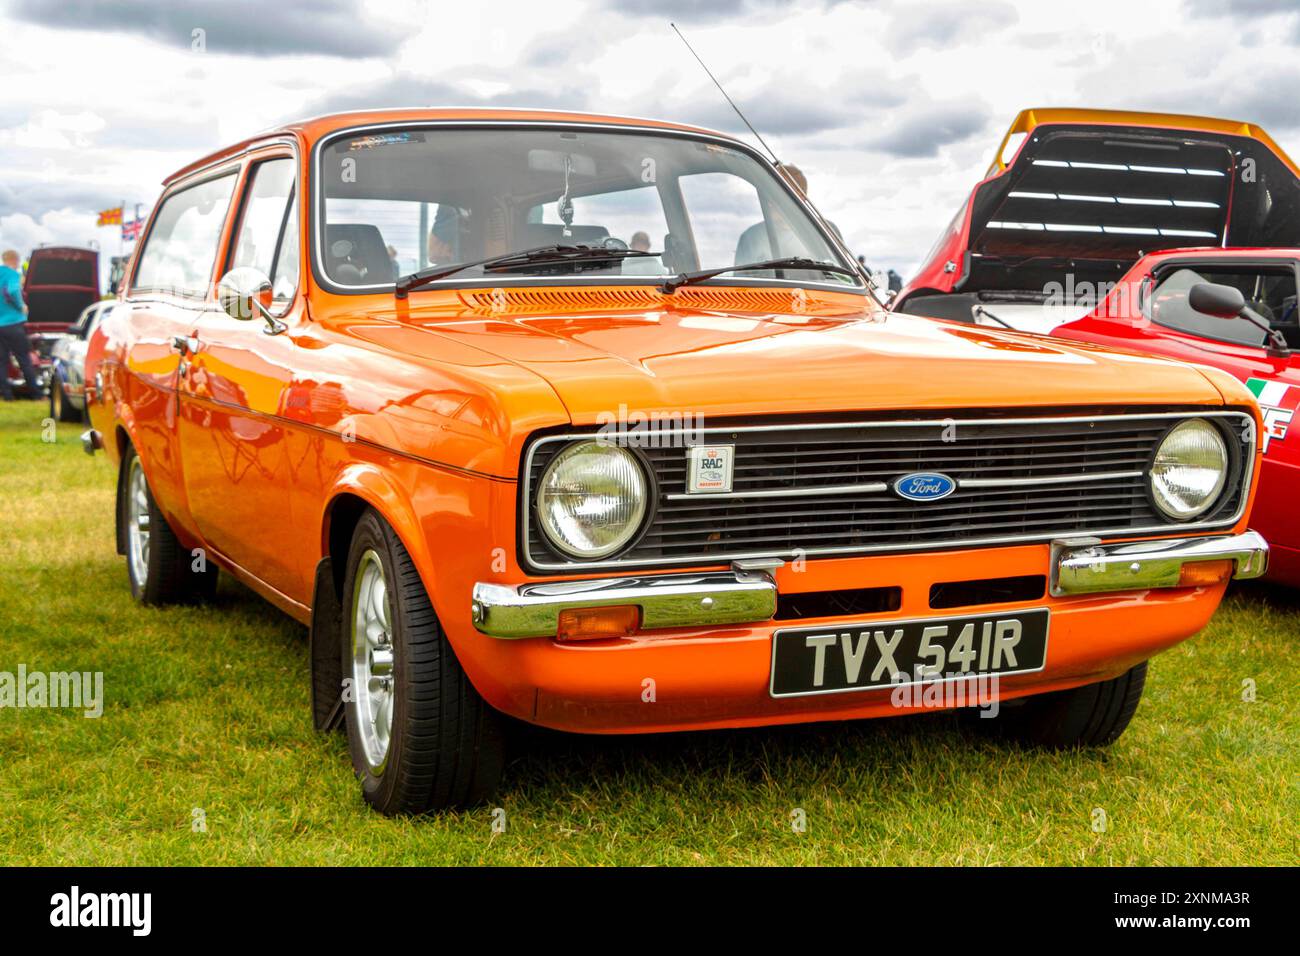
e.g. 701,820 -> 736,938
520,408 -> 1258,572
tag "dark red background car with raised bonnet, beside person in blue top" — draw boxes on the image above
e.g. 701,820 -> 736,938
18,246 -> 99,398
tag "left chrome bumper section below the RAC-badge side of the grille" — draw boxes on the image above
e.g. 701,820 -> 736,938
471,571 -> 776,640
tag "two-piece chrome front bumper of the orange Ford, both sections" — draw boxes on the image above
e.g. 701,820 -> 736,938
472,531 -> 1269,640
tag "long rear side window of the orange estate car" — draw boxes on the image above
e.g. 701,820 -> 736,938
131,173 -> 235,298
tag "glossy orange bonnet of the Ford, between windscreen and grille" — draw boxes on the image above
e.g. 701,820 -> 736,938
372,293 -> 1222,424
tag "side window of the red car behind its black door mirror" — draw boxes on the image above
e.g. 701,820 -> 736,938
1148,265 -> 1300,347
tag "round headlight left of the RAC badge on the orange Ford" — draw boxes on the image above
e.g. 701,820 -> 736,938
537,441 -> 649,558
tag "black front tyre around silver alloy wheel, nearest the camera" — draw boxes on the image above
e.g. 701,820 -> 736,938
339,510 -> 504,816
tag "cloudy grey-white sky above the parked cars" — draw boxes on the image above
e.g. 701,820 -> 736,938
0,0 -> 1300,283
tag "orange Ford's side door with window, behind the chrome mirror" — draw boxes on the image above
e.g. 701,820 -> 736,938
178,152 -> 303,602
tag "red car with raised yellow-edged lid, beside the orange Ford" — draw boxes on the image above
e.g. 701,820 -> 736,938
892,111 -> 1300,587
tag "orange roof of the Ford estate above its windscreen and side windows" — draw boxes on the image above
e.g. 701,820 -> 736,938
163,107 -> 744,186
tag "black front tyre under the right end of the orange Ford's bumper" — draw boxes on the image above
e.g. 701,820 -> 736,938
972,661 -> 1147,750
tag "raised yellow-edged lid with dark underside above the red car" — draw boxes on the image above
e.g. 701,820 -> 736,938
901,111 -> 1300,308
